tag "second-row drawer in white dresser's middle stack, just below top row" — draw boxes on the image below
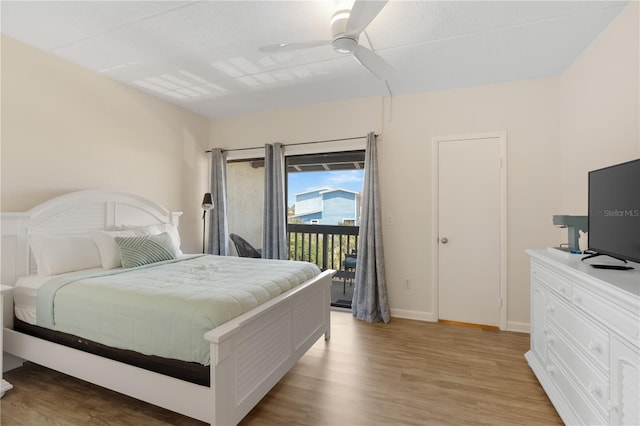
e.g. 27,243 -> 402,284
547,288 -> 610,372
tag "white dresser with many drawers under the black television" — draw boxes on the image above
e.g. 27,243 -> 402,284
525,249 -> 640,425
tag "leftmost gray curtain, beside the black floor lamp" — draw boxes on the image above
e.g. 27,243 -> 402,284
207,148 -> 229,256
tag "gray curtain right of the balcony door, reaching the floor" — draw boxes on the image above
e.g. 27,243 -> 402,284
351,133 -> 391,323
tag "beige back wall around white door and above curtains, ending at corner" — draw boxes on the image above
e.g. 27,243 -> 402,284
212,78 -> 560,323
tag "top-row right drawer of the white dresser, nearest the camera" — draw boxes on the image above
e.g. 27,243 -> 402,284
572,286 -> 640,346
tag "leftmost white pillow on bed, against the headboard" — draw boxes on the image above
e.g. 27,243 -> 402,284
29,234 -> 101,276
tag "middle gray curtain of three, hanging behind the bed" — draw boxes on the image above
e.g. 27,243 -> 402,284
262,143 -> 289,259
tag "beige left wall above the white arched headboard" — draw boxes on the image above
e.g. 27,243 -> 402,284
0,36 -> 209,252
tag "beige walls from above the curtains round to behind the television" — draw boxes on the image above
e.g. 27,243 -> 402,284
211,4 -> 639,330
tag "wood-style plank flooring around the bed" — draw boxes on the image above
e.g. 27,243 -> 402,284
0,312 -> 562,426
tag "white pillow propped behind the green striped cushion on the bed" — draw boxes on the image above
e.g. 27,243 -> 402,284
93,223 -> 182,269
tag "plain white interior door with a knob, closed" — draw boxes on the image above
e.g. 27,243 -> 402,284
434,135 -> 506,328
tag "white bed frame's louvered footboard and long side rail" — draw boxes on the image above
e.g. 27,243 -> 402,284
4,270 -> 335,426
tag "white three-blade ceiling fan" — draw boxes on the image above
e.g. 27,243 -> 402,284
260,0 -> 393,80
